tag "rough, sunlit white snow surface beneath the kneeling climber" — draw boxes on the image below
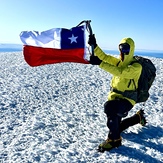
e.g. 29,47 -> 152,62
0,52 -> 163,163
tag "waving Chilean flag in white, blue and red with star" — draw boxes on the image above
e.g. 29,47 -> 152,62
20,26 -> 89,67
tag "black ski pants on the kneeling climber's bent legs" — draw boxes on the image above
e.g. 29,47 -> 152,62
104,99 -> 140,140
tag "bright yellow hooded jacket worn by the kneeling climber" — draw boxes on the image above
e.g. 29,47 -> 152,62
95,38 -> 142,105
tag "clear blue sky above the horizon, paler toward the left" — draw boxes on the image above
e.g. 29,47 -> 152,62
0,0 -> 163,51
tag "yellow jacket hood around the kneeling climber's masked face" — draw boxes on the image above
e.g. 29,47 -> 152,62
120,38 -> 135,66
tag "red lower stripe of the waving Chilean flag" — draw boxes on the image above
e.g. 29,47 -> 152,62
23,45 -> 89,67
